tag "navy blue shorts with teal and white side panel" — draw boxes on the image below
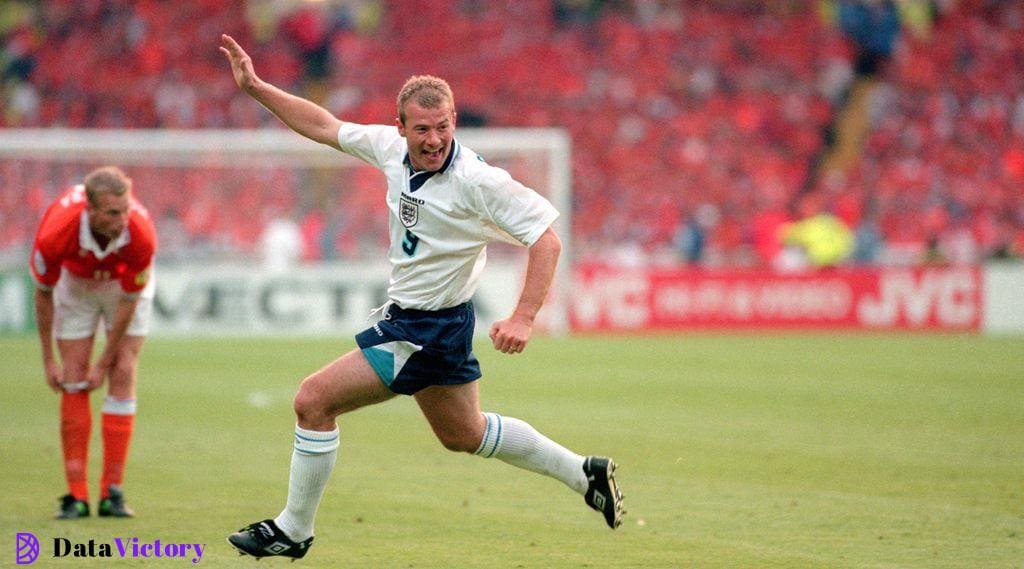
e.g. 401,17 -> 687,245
355,302 -> 480,395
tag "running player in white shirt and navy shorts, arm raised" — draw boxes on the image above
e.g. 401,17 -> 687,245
220,35 -> 624,559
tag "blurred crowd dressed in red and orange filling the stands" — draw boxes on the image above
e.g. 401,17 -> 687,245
0,0 -> 1024,268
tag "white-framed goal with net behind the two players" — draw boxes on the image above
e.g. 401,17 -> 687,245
0,128 -> 572,334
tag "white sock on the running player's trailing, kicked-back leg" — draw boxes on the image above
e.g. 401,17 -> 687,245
475,412 -> 587,494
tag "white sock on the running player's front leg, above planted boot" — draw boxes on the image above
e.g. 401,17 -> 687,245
273,425 -> 340,541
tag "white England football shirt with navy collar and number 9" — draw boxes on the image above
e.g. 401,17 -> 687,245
338,123 -> 558,310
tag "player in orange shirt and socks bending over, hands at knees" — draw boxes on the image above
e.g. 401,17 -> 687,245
29,166 -> 157,519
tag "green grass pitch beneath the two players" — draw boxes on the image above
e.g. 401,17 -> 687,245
0,334 -> 1024,569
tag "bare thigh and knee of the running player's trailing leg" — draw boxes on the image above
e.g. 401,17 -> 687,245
413,382 -> 485,452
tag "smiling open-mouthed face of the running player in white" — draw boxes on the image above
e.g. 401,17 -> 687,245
396,100 -> 455,171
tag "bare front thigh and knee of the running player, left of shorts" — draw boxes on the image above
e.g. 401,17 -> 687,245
295,350 -> 395,428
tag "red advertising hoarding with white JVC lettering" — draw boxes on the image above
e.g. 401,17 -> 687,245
569,265 -> 984,332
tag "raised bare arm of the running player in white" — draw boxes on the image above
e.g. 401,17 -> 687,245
220,34 -> 342,149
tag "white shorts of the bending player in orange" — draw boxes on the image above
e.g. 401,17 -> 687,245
53,269 -> 157,340
